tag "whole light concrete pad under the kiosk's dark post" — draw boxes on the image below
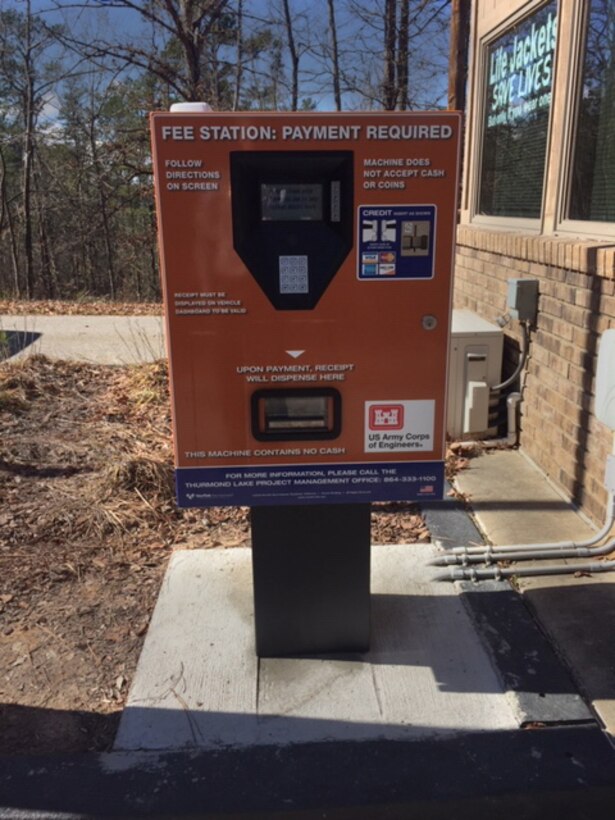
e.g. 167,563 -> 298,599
115,545 -> 518,750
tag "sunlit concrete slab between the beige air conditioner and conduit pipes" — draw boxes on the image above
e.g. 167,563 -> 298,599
455,450 -> 595,545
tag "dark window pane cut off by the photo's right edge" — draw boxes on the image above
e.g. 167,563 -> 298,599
568,0 -> 615,222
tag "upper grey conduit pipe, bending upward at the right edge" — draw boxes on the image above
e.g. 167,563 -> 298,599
430,490 -> 615,567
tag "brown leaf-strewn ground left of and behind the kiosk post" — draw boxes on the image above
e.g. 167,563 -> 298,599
0,356 -> 429,754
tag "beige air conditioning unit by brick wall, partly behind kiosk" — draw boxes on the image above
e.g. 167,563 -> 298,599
446,310 -> 504,439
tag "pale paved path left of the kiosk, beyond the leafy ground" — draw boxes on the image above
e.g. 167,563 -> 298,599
0,315 -> 166,364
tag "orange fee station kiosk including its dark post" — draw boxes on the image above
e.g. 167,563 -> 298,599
151,105 -> 460,655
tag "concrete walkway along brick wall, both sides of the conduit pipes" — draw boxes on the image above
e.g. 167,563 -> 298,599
455,450 -> 615,737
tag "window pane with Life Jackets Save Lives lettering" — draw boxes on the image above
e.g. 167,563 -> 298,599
479,0 -> 557,219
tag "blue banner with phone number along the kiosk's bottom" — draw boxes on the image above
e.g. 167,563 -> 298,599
175,461 -> 444,507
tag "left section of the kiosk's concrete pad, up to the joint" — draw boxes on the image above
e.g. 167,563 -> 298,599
116,550 -> 258,749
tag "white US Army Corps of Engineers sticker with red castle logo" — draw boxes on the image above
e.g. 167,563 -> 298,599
365,399 -> 436,453
